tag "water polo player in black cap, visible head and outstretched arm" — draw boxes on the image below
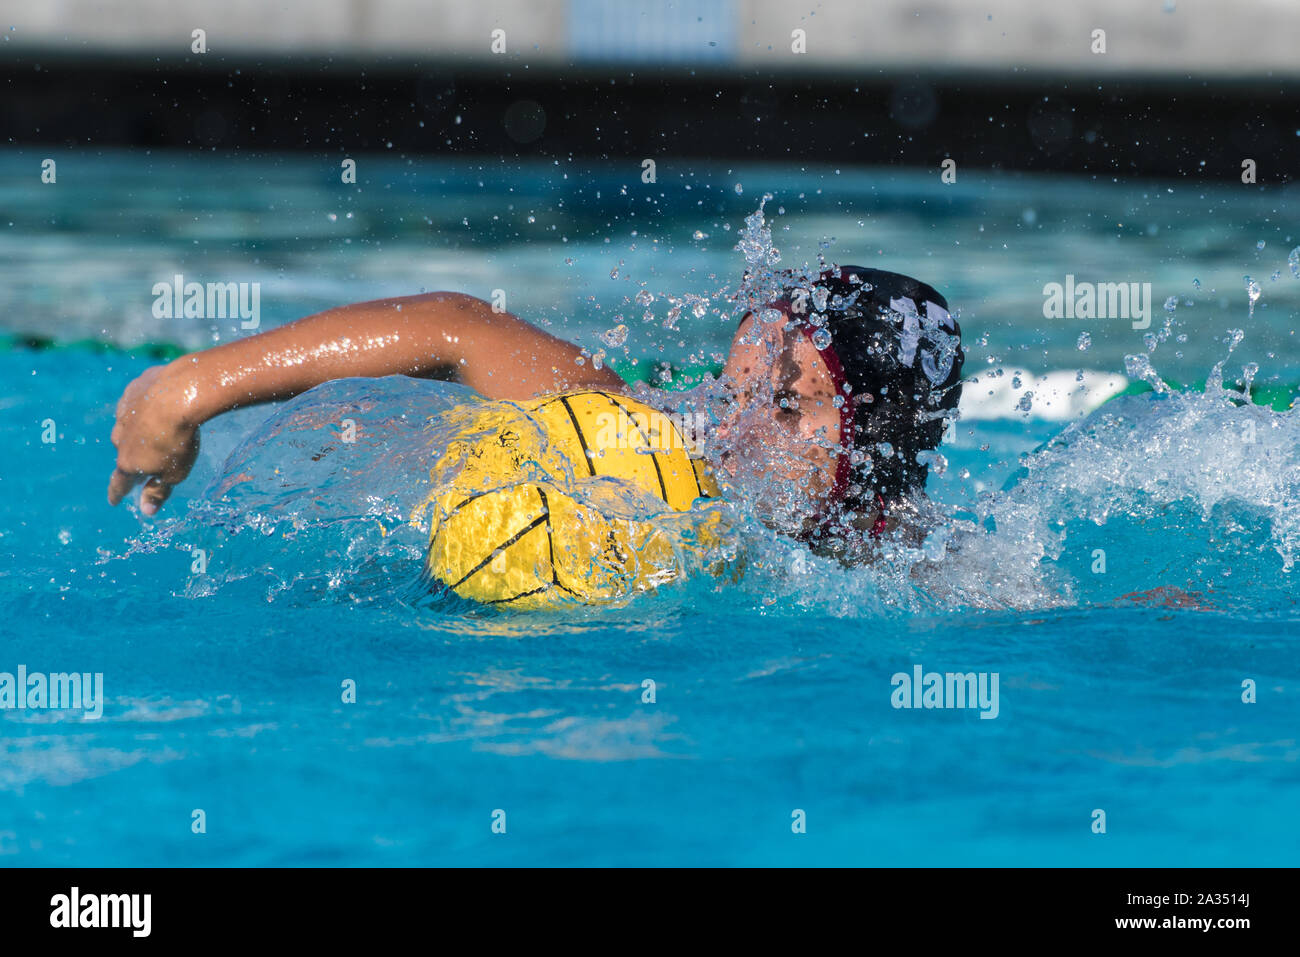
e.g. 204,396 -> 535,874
108,267 -> 963,554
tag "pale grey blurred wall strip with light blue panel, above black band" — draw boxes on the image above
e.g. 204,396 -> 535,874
0,0 -> 1300,75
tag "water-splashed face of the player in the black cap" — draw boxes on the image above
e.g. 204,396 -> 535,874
722,310 -> 840,505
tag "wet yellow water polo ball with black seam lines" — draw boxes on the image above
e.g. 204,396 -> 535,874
425,391 -> 722,607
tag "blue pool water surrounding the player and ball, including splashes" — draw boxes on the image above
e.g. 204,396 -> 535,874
0,151 -> 1300,865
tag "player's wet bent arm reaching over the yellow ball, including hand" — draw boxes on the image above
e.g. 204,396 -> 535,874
108,293 -> 625,515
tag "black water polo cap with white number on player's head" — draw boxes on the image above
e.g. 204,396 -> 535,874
774,265 -> 965,510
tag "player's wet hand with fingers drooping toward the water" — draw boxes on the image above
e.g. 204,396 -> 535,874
108,365 -> 199,515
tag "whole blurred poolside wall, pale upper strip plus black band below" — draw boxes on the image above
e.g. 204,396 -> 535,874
0,0 -> 1300,176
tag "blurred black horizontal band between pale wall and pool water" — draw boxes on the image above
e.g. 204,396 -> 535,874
0,53 -> 1300,185
